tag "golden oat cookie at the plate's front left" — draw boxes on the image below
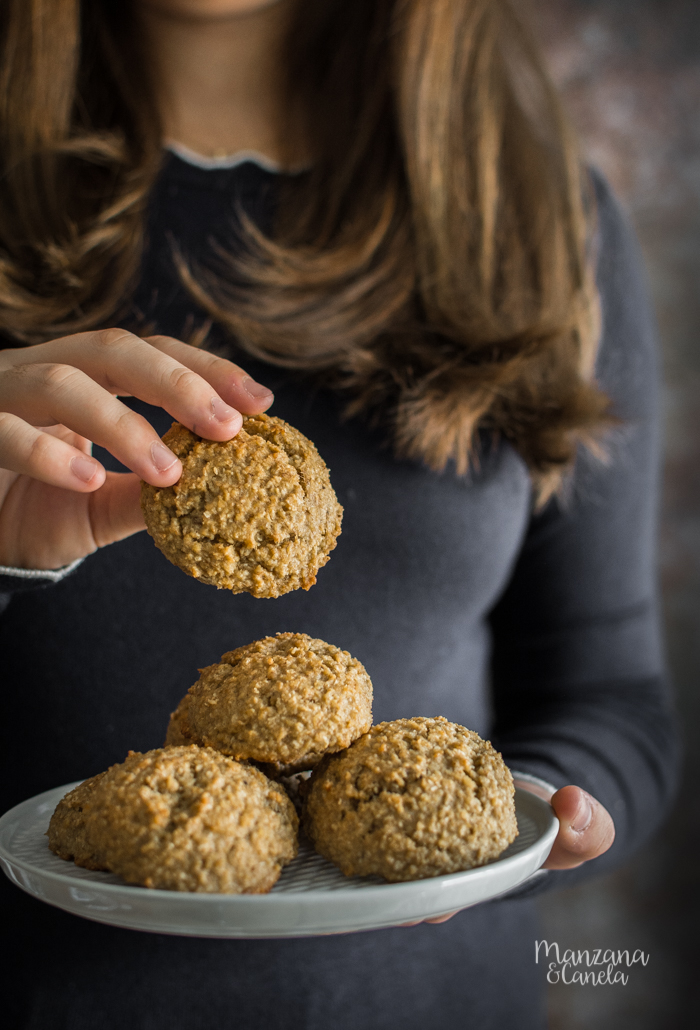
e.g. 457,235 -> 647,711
60,746 -> 299,894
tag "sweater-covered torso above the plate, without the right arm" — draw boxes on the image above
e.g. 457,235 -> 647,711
0,158 -> 530,809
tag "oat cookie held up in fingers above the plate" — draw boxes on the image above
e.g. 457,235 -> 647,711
141,415 -> 343,597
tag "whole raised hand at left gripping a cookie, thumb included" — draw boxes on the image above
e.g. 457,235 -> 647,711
0,329 -> 273,570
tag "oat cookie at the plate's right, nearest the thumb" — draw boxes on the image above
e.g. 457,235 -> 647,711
304,718 -> 518,882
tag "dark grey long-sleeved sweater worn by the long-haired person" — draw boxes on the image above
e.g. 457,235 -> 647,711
0,157 -> 677,1030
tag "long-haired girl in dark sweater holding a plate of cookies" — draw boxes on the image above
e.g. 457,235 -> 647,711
0,0 -> 676,1030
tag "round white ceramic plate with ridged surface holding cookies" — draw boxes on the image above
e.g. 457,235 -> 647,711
0,774 -> 559,937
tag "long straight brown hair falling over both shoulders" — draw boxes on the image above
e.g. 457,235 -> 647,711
0,0 -> 607,500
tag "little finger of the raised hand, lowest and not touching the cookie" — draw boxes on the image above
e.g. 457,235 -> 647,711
0,412 -> 105,493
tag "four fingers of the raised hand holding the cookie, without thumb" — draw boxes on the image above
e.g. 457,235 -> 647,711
0,330 -> 273,490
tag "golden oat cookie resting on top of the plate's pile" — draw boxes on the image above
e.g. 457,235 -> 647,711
167,633 -> 372,774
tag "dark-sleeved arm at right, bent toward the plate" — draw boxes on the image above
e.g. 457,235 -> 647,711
492,173 -> 678,882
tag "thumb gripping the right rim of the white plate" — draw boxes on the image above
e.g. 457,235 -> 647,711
545,786 -> 615,869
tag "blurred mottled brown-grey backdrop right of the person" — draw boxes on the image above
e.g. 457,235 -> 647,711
527,0 -> 700,1030
